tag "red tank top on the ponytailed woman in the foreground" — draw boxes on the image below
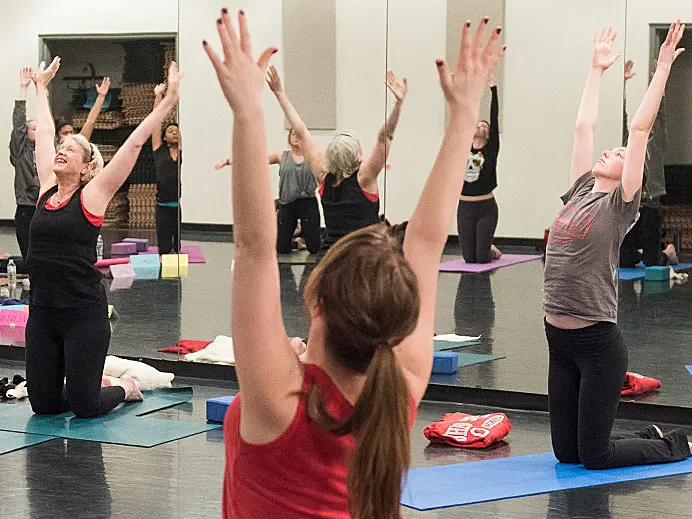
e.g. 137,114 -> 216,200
223,364 -> 416,519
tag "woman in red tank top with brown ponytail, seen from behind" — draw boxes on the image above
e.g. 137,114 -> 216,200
204,9 -> 504,519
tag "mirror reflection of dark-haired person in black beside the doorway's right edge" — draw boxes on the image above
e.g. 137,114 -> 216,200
151,84 -> 183,254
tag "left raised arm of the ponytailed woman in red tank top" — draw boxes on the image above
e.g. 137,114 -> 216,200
204,9 -> 302,440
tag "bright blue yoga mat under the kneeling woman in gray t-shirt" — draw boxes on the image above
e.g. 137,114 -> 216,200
401,452 -> 692,510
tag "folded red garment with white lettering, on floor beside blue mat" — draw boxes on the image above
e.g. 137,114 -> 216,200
423,413 -> 512,449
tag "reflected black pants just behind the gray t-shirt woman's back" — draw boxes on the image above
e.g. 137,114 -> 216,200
620,205 -> 668,267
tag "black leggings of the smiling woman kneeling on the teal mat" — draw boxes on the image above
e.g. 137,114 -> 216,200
26,305 -> 125,418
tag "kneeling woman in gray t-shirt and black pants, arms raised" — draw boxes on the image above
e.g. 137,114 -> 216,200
543,21 -> 690,469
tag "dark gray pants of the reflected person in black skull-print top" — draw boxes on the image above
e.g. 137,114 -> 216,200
457,198 -> 498,263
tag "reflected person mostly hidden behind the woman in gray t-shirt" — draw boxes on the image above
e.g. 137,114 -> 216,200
620,60 -> 678,267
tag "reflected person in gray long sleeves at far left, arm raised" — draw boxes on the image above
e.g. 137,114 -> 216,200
10,67 -> 39,261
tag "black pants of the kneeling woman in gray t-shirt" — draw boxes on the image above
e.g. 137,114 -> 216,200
545,322 -> 690,469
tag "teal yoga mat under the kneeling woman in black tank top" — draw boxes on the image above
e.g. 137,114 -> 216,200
0,387 -> 219,447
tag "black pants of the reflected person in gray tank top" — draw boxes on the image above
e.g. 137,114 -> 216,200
276,198 -> 320,254
